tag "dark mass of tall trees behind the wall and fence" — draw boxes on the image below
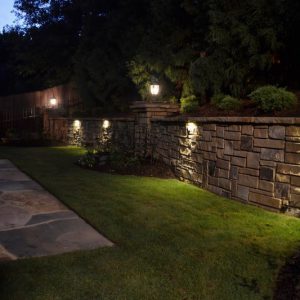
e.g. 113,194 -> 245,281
0,0 -> 300,112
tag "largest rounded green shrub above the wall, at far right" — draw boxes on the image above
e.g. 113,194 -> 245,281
249,85 -> 297,112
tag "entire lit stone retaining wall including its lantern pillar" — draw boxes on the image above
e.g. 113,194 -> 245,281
44,103 -> 300,215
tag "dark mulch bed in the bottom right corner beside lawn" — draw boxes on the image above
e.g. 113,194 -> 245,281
273,252 -> 300,300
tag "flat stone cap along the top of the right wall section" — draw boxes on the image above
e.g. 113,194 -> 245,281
152,116 -> 300,125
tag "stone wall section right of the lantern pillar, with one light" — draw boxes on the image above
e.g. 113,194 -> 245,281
151,117 -> 300,211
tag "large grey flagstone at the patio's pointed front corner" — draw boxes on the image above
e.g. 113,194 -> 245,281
0,218 -> 113,258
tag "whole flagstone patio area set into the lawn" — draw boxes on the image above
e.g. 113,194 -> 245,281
0,159 -> 113,262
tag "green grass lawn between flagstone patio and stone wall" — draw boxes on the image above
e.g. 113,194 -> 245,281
0,147 -> 300,300
